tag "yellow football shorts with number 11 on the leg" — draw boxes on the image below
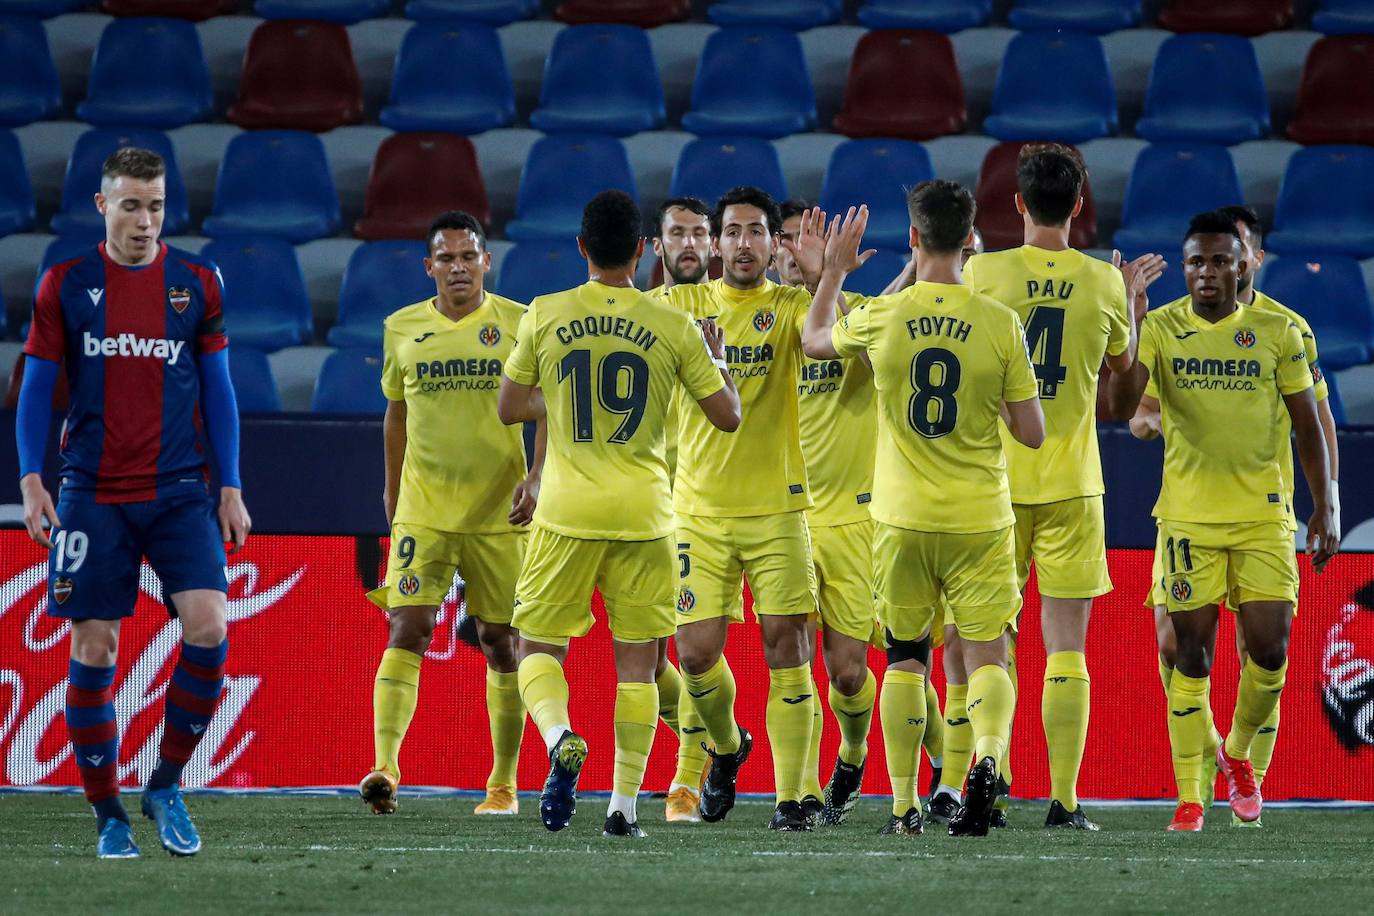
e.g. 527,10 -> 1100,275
1150,519 -> 1297,614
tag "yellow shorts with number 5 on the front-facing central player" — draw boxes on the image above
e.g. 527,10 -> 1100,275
677,509 -> 816,626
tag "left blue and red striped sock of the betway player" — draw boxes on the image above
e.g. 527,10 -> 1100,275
66,659 -> 129,829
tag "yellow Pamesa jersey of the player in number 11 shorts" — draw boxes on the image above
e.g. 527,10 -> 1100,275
1140,299 -> 1312,522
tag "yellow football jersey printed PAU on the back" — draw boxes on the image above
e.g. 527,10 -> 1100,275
963,244 -> 1131,505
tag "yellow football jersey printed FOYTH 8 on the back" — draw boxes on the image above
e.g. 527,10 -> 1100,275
831,282 -> 1036,534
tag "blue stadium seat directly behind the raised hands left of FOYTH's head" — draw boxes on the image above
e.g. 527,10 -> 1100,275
820,140 -> 936,248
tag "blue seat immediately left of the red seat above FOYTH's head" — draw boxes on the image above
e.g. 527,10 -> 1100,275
683,29 -> 816,137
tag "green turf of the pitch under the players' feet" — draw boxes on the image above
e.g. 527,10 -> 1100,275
0,795 -> 1374,916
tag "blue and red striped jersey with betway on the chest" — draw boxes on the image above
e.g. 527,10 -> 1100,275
23,242 -> 228,503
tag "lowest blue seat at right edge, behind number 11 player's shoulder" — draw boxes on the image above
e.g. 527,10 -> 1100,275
1257,255 -> 1374,374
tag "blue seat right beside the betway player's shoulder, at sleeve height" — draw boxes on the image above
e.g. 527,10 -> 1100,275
201,235 -> 315,353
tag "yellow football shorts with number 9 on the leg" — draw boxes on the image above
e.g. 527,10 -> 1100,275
367,522 -> 526,623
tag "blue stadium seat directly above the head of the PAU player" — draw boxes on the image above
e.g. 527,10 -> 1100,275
982,32 -> 1117,143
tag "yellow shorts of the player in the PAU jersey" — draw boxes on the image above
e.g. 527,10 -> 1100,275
1011,496 -> 1112,597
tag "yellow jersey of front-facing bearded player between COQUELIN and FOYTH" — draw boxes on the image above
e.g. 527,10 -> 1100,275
668,280 -> 811,518
